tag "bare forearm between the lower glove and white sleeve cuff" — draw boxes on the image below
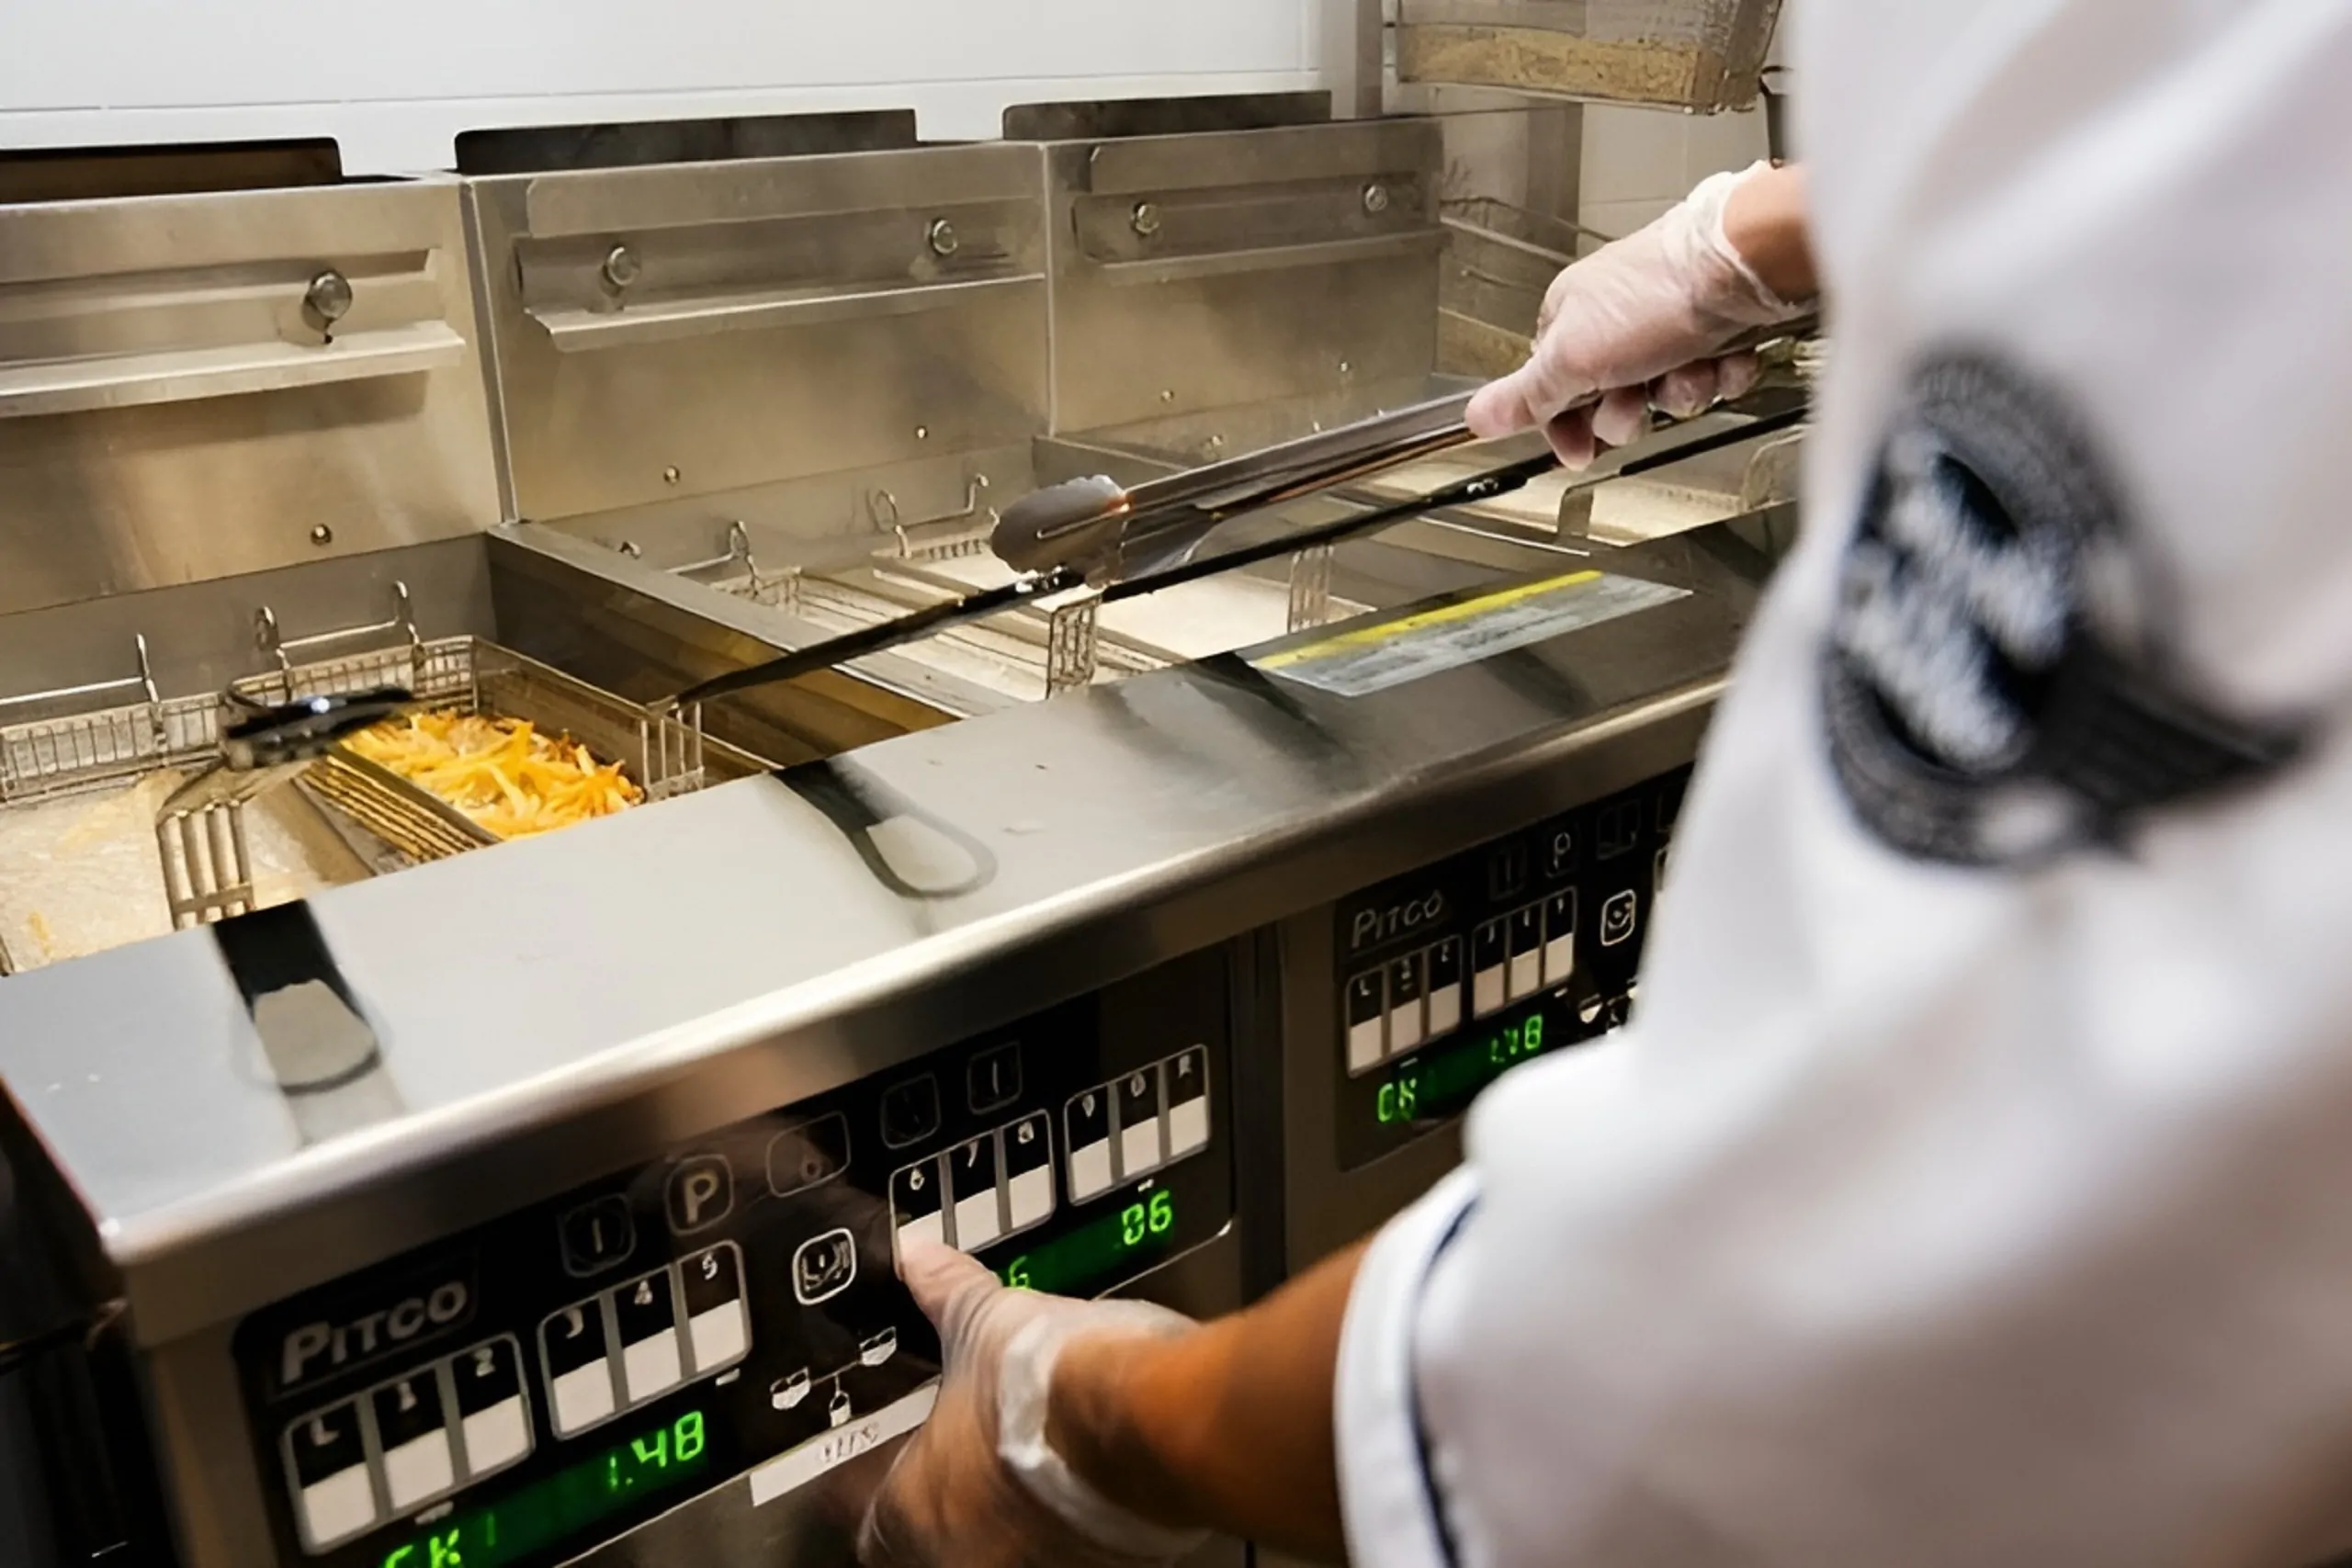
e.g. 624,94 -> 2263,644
1046,1246 -> 1364,1561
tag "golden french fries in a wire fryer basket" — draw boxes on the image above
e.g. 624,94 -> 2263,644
344,707 -> 644,840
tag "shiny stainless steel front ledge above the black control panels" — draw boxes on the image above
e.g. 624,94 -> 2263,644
0,536 -> 1752,1342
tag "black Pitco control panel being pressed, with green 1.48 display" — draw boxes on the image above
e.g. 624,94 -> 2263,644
235,952 -> 1235,1568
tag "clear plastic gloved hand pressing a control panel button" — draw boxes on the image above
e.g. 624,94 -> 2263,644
858,1244 -> 1206,1568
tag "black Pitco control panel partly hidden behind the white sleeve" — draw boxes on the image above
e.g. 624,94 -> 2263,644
1334,769 -> 1691,1170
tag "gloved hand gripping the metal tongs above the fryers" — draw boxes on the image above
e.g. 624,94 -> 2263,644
1467,164 -> 1804,468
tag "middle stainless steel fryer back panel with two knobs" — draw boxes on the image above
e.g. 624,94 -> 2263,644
468,146 -> 1046,520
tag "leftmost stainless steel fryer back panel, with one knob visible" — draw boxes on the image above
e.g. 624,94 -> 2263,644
0,171 -> 499,611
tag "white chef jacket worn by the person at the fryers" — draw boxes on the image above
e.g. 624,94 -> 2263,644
1339,0 -> 2352,1568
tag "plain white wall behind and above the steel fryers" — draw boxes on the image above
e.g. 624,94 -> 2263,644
0,0 -> 1327,174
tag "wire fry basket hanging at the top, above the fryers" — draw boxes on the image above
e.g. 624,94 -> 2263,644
1397,0 -> 1781,113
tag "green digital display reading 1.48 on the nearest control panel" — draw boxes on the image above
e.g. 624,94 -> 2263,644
381,1411 -> 710,1568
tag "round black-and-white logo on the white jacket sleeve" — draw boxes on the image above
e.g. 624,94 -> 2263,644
1823,355 -> 2301,865
